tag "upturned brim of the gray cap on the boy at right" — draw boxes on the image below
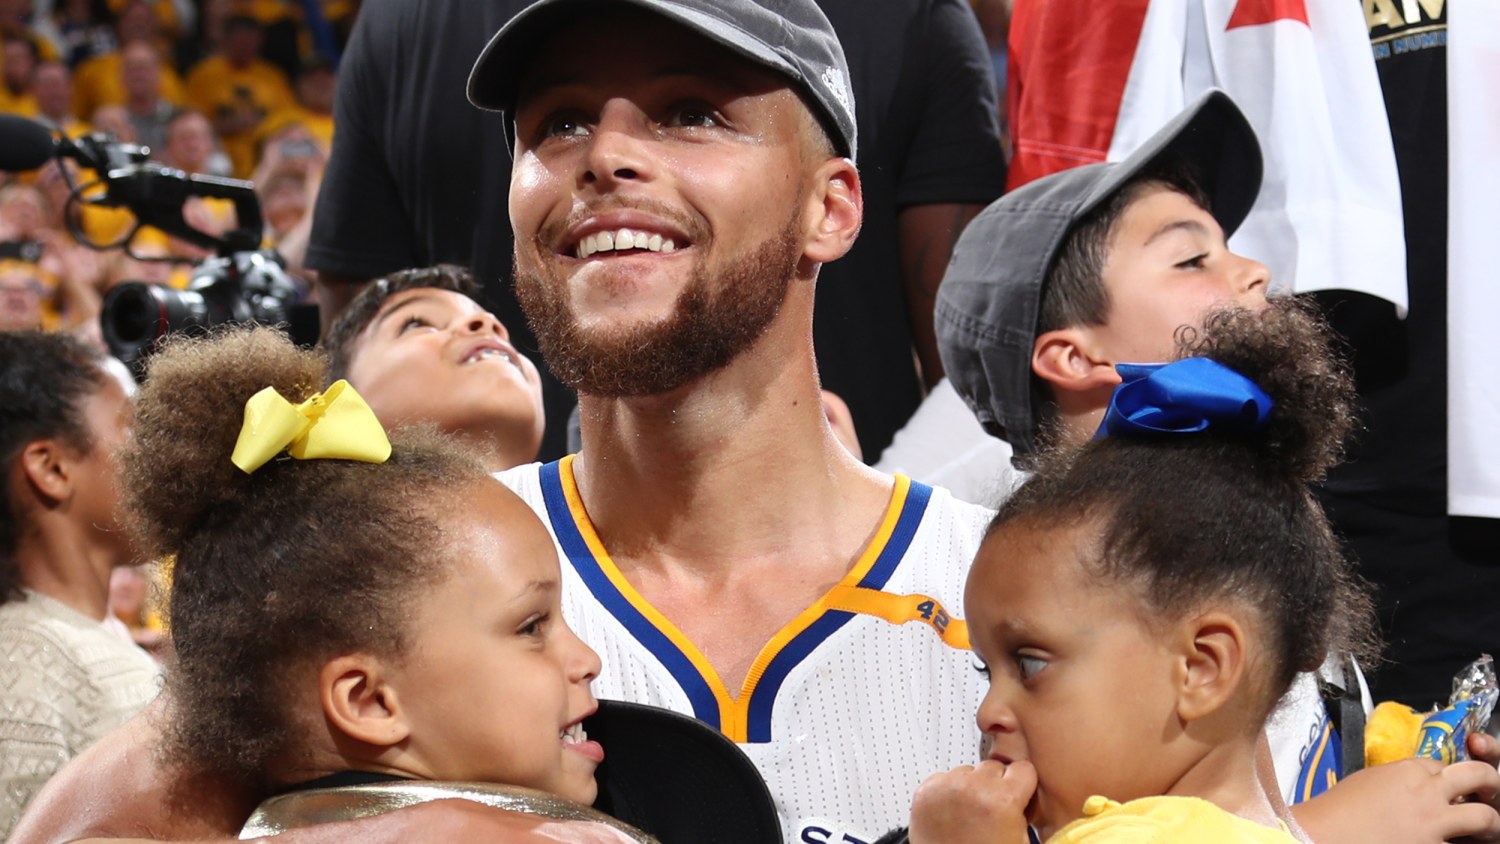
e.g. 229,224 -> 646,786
1079,88 -> 1265,237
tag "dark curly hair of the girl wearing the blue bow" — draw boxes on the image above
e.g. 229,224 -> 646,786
990,298 -> 1376,711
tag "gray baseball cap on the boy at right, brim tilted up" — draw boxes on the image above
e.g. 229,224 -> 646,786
935,88 -> 1262,456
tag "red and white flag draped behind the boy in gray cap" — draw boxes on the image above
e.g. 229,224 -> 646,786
1010,0 -> 1407,309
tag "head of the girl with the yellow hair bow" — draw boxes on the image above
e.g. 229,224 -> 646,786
122,328 -> 630,833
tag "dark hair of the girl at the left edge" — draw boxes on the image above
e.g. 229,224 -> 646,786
0,331 -> 110,604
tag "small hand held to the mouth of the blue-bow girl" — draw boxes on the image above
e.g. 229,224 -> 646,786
911,760 -> 1037,844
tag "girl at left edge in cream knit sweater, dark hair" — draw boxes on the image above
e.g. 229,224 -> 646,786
0,331 -> 161,838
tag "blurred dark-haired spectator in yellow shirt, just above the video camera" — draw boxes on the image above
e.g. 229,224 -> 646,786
188,15 -> 296,178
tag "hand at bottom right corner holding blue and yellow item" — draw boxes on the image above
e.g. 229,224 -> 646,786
1292,759 -> 1500,844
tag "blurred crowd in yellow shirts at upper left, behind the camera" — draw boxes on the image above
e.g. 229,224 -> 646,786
0,0 -> 348,342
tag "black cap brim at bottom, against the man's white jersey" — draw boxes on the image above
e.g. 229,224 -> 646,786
584,700 -> 782,844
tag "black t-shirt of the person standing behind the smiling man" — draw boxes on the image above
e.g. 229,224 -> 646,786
306,0 -> 1005,460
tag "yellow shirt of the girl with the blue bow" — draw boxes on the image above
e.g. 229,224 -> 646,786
1047,796 -> 1296,844
